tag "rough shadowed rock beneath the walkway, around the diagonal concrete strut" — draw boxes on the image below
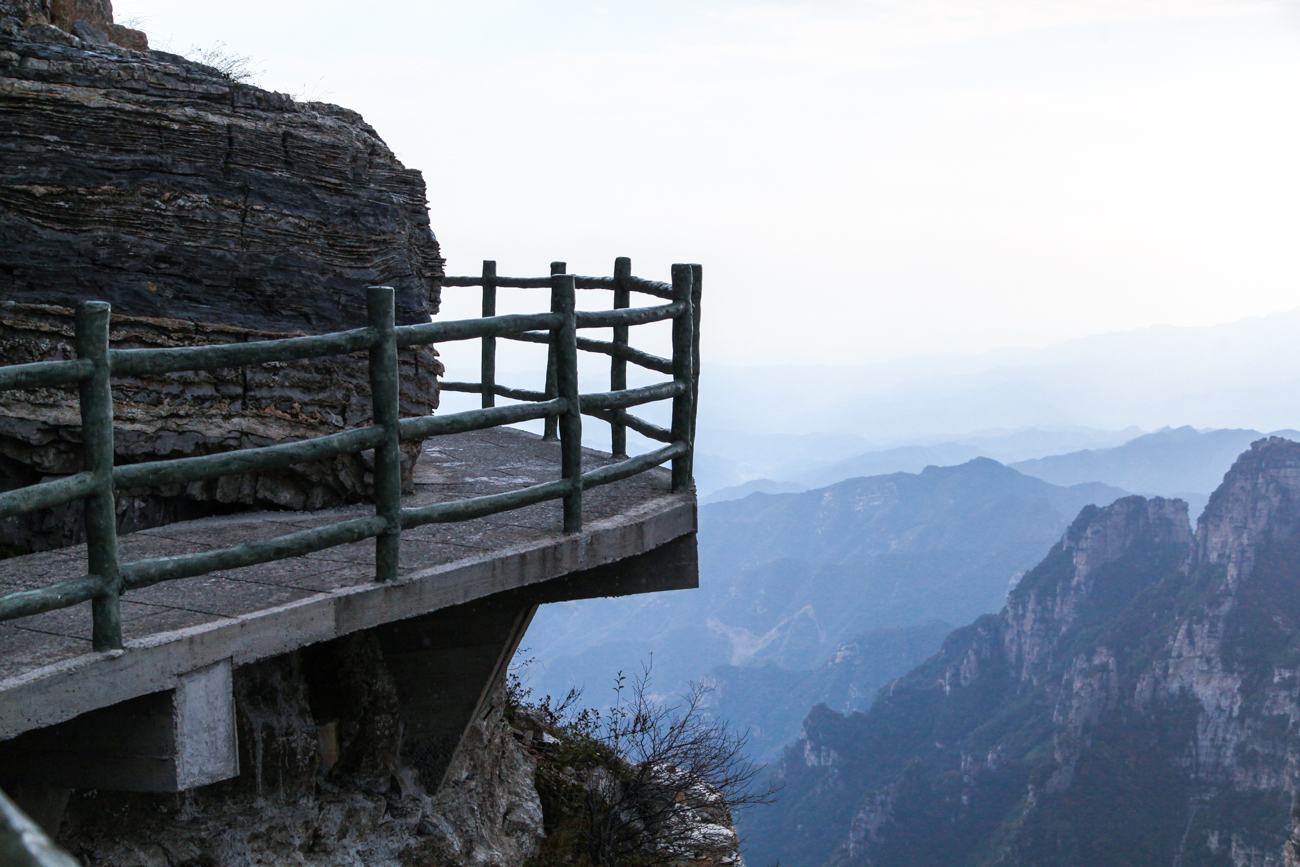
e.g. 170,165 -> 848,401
59,634 -> 543,867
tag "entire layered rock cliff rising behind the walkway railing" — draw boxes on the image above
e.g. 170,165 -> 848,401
0,0 -> 442,550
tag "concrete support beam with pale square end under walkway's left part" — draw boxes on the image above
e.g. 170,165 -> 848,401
0,659 -> 239,792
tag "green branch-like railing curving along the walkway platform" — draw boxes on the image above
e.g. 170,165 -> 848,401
0,259 -> 702,650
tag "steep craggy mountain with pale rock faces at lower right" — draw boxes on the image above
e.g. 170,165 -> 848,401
750,438 -> 1300,867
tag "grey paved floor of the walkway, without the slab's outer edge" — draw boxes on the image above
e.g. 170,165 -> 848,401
0,428 -> 676,701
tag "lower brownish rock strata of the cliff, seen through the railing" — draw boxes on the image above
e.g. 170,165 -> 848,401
0,302 -> 442,550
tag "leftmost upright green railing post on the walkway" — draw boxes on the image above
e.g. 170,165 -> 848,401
75,302 -> 122,650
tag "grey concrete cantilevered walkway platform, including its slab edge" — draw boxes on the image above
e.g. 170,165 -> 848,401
0,428 -> 698,743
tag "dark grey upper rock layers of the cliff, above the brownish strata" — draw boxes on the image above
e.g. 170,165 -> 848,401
0,3 -> 442,331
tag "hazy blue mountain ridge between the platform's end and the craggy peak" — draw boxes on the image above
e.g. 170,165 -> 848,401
525,458 -> 1126,745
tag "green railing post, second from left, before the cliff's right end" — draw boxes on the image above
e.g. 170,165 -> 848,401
365,286 -> 402,581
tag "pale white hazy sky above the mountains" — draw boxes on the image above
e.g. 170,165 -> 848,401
114,0 -> 1300,364
